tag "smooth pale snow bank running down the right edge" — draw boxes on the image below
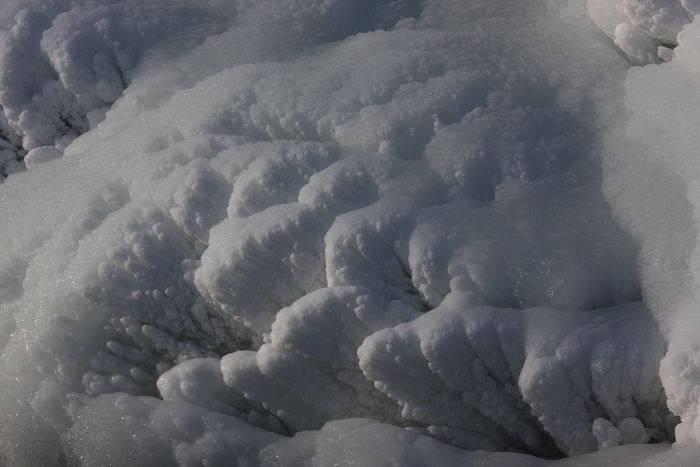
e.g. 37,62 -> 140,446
606,13 -> 700,450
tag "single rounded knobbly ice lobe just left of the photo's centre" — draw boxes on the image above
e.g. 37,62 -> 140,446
195,204 -> 324,334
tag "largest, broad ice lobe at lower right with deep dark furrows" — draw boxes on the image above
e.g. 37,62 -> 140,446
358,294 -> 669,456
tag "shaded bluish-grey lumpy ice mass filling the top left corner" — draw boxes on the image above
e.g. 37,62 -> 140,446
0,0 -> 233,174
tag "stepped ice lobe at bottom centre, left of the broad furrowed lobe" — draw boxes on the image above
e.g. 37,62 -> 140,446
221,287 -> 418,433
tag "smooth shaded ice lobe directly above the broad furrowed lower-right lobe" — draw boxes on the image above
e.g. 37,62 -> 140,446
408,183 -> 639,310
